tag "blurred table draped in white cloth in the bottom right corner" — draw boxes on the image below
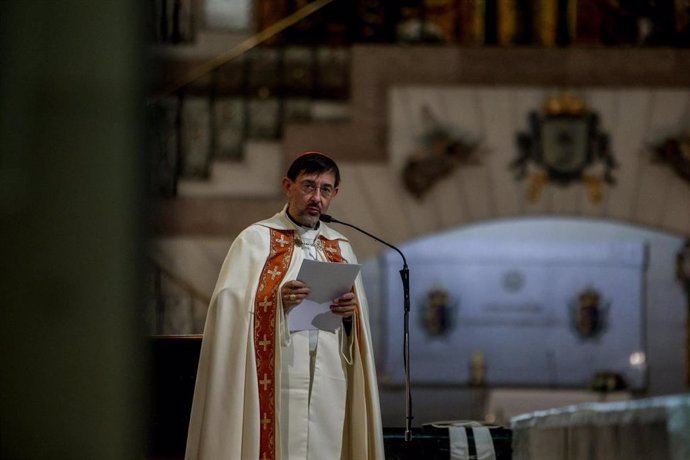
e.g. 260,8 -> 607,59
510,394 -> 690,460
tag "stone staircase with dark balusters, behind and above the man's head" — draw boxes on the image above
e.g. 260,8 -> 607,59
150,28 -> 351,197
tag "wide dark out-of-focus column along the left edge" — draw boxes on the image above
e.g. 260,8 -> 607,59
0,0 -> 147,460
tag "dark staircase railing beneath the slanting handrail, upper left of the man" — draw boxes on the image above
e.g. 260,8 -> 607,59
148,0 -> 340,197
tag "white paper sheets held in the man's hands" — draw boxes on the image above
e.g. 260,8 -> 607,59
288,259 -> 361,331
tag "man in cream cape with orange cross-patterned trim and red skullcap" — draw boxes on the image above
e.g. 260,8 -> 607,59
186,152 -> 384,460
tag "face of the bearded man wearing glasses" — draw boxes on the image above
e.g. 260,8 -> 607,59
283,172 -> 338,227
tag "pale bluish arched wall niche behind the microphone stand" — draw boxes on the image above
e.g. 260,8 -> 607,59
363,217 -> 687,394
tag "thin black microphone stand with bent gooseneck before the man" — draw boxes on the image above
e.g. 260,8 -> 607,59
319,214 -> 414,442
